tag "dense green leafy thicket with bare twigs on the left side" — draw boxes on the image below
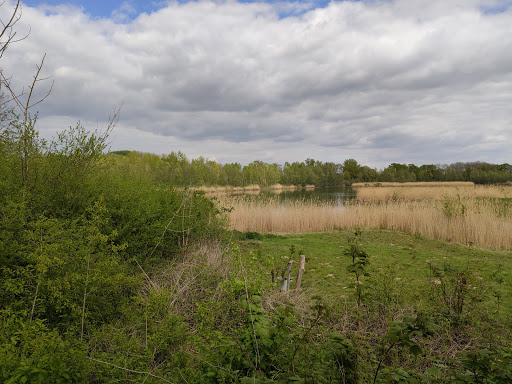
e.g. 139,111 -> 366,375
0,1 -> 225,376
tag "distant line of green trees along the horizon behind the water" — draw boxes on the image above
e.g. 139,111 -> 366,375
109,151 -> 512,187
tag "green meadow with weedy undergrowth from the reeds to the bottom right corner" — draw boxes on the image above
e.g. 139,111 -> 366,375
242,229 -> 512,383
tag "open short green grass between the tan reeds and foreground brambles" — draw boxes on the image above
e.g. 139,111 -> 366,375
244,229 -> 512,321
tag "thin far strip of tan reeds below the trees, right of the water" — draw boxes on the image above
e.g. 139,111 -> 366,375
356,184 -> 512,201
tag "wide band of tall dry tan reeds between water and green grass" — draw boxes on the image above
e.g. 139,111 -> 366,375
225,187 -> 512,249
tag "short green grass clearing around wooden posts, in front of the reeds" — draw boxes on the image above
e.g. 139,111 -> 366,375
241,229 -> 512,325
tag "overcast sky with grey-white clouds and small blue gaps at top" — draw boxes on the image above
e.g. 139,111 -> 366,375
0,0 -> 512,168
